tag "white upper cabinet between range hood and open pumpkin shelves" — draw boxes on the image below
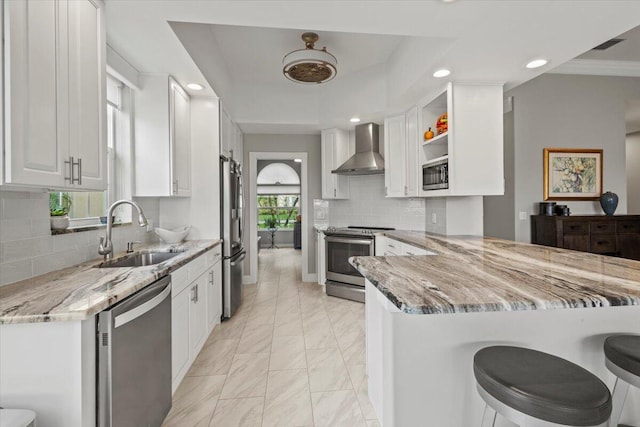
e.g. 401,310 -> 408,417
384,107 -> 418,197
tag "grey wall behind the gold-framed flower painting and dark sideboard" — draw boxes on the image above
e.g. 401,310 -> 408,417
496,74 -> 640,242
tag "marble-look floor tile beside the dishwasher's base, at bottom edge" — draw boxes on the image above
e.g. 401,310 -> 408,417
162,375 -> 226,427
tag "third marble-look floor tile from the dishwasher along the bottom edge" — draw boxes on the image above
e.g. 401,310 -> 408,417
262,369 -> 313,427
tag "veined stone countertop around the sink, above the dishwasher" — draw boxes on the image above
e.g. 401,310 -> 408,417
0,239 -> 221,324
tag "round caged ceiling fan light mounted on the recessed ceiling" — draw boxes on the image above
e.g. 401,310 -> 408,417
282,32 -> 338,84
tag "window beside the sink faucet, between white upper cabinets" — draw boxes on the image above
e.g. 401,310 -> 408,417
49,76 -> 132,227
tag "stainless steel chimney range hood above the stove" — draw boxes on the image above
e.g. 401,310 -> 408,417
331,123 -> 384,175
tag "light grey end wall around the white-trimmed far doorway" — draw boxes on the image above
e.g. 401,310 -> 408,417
243,134 -> 322,275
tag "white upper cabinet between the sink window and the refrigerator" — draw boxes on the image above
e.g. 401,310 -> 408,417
134,75 -> 191,197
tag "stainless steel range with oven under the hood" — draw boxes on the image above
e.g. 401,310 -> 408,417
324,226 -> 393,302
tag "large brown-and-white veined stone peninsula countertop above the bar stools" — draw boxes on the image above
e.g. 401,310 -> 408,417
350,231 -> 640,320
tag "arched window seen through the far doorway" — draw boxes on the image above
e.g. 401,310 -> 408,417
257,161 -> 300,229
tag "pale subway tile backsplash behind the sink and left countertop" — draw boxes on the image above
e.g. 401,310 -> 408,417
0,191 -> 159,286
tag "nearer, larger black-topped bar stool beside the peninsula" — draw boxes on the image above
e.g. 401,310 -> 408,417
473,346 -> 611,427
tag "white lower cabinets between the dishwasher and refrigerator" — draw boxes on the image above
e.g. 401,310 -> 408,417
171,246 -> 222,392
